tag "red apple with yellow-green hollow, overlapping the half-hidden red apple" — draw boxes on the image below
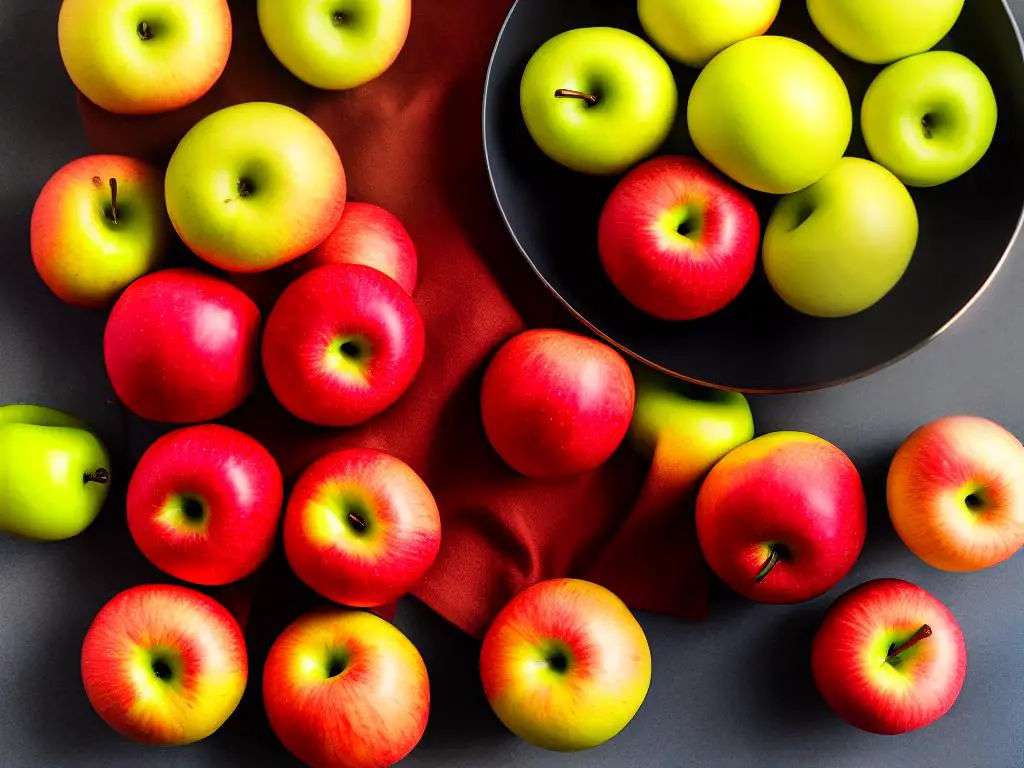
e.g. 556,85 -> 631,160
263,264 -> 426,427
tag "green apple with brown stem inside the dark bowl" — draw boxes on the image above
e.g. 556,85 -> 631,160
519,27 -> 679,175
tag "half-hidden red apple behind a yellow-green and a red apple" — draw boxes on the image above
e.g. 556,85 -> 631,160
292,203 -> 418,295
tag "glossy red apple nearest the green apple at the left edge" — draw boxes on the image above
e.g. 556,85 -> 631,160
127,424 -> 284,586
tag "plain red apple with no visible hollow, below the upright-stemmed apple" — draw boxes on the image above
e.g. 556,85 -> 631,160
103,268 -> 260,424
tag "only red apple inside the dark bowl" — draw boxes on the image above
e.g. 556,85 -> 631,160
598,156 -> 761,321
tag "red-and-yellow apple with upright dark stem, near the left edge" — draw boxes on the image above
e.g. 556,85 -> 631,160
31,155 -> 171,308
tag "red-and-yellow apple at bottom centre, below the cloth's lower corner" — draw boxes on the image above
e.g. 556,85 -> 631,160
480,579 -> 650,752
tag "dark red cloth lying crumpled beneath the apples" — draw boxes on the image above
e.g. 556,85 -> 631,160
79,0 -> 707,635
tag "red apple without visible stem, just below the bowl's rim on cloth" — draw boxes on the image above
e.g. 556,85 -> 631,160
480,329 -> 636,477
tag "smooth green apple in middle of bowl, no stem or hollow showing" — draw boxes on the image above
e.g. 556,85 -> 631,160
686,36 -> 853,195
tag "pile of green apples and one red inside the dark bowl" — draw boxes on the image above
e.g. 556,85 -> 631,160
520,0 -> 997,321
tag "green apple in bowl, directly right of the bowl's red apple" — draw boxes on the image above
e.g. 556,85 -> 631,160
762,158 -> 918,317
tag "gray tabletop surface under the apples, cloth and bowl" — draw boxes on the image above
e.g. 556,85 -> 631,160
0,0 -> 1024,768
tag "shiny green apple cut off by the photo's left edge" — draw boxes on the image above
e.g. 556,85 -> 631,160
0,404 -> 111,541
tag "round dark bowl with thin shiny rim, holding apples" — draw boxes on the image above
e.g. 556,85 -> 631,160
483,0 -> 1024,392
